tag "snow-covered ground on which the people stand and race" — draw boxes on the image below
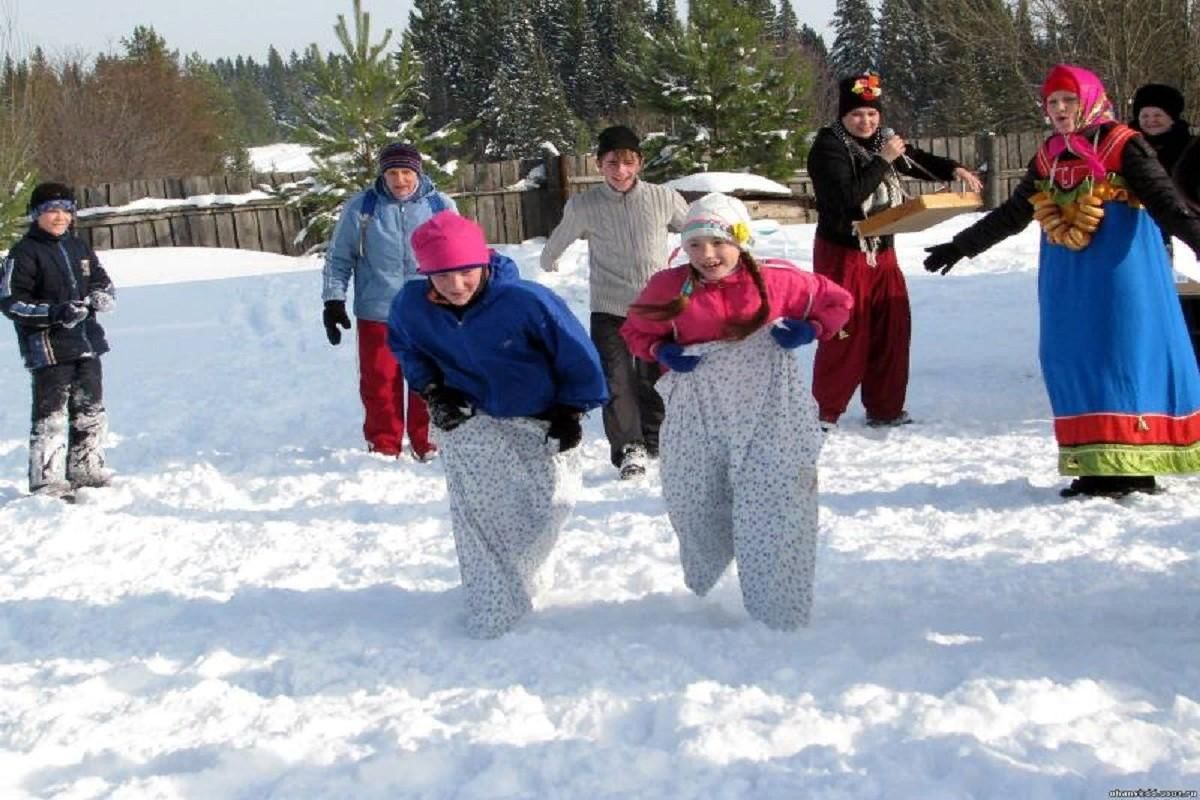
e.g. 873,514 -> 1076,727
0,219 -> 1200,800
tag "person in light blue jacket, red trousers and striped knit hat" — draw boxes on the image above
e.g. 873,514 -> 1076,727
320,143 -> 455,461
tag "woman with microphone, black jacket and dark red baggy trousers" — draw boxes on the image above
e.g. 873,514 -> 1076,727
808,72 -> 982,429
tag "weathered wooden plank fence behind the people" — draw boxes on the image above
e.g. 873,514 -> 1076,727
77,132 -> 1044,254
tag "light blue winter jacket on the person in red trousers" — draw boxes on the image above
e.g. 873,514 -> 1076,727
320,174 -> 456,323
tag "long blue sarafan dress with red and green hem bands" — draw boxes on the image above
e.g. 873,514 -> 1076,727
1036,125 -> 1200,475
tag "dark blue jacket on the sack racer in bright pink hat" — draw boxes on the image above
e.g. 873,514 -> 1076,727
388,251 -> 608,417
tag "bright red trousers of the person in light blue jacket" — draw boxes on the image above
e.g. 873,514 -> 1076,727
358,319 -> 432,456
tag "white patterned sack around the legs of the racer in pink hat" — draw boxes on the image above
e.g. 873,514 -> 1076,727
434,414 -> 581,638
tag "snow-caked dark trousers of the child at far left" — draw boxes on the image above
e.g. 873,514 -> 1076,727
29,359 -> 108,492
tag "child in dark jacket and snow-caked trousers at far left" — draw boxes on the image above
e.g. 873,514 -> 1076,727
0,184 -> 115,498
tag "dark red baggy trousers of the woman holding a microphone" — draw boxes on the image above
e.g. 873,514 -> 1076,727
812,236 -> 912,422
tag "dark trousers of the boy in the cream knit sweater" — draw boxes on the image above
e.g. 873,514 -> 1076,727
592,312 -> 664,467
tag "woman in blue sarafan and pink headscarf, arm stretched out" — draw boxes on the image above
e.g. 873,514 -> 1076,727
925,65 -> 1200,497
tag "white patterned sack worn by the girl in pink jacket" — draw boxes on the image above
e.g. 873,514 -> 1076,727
658,326 -> 822,630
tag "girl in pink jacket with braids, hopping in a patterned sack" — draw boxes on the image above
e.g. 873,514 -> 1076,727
620,193 -> 853,630
